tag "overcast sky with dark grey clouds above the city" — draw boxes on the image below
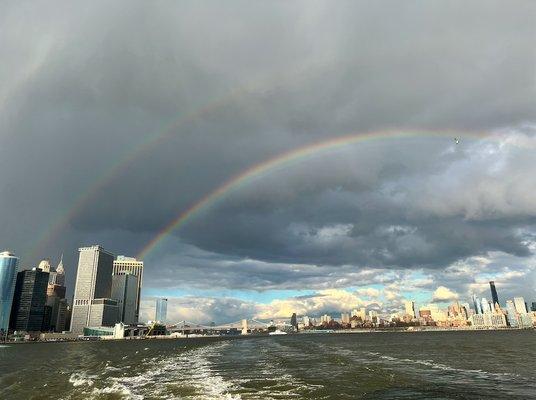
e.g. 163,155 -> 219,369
0,0 -> 536,322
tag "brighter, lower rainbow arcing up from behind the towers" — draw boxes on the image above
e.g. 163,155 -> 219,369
137,130 -> 490,259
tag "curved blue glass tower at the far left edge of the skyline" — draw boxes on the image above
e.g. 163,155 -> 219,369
0,251 -> 19,335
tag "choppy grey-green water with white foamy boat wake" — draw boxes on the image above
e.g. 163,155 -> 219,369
0,330 -> 536,400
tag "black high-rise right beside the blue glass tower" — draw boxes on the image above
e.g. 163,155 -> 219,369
9,268 -> 48,332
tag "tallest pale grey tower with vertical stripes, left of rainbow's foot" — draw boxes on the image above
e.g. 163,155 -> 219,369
71,246 -> 117,334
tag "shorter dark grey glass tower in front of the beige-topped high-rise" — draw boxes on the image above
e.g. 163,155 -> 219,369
112,272 -> 138,325
